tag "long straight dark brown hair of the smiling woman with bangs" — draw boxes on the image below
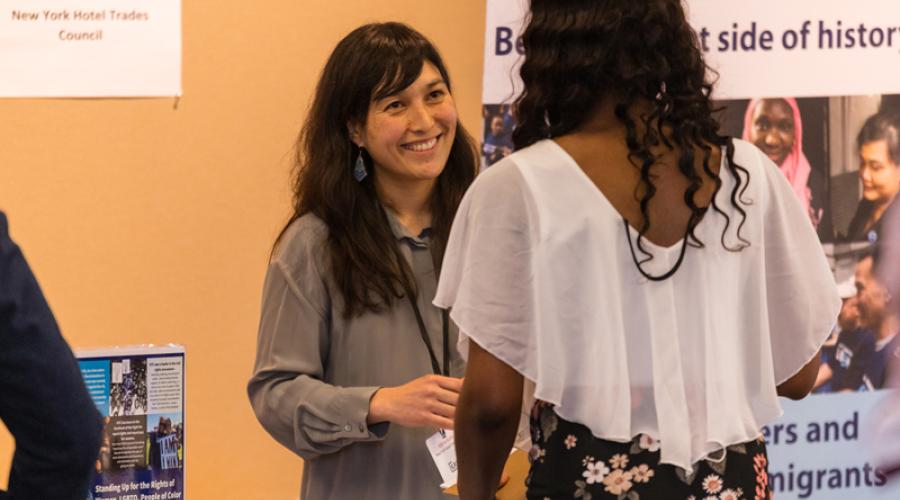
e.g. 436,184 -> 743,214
275,23 -> 478,317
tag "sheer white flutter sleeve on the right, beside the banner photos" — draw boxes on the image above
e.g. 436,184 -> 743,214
760,150 -> 841,384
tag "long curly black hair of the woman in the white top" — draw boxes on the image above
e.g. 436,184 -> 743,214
513,0 -> 750,258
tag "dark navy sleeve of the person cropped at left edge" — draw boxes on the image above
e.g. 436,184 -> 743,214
0,213 -> 102,500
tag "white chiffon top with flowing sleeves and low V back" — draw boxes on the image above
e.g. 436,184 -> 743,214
434,140 -> 841,471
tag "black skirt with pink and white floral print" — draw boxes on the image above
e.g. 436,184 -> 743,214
527,401 -> 771,500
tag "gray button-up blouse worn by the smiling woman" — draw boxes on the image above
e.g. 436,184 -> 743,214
248,213 -> 463,500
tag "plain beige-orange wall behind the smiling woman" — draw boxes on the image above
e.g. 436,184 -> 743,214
0,0 -> 485,500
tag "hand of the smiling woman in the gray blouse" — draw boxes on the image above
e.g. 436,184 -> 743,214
366,375 -> 462,429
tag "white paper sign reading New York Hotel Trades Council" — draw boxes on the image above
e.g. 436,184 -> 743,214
0,0 -> 181,97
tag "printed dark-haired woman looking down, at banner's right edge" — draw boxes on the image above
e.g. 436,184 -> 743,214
844,114 -> 900,243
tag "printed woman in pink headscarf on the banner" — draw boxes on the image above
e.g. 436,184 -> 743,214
742,97 -> 833,241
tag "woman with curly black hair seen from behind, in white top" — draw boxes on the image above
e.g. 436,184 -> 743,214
435,0 -> 841,499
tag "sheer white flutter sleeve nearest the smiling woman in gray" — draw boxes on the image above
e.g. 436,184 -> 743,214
434,161 -> 539,381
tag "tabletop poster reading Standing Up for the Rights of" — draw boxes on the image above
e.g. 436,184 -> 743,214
78,346 -> 185,500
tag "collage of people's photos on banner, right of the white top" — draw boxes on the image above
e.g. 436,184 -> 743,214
716,95 -> 900,393
